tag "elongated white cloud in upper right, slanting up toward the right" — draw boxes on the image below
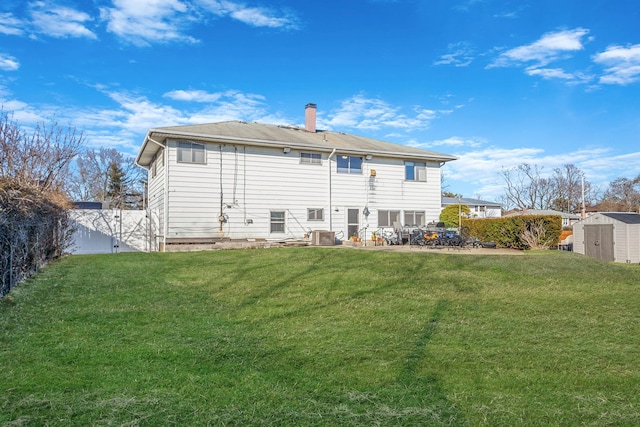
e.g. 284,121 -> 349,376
489,28 -> 589,67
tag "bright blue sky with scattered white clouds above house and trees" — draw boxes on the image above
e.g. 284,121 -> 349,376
0,0 -> 640,200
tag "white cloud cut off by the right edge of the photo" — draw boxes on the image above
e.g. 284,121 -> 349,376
593,44 -> 640,85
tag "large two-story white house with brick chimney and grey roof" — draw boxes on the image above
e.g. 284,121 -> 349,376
136,104 -> 455,250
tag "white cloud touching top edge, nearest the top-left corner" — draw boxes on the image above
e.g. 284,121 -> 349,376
30,1 -> 97,39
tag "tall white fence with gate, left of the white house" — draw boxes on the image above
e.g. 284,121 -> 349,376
69,209 -> 149,254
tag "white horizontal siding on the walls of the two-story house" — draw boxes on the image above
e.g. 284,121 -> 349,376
160,140 -> 448,239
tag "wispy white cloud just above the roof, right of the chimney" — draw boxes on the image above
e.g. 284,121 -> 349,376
322,95 -> 440,130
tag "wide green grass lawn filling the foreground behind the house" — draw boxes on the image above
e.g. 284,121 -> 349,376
0,248 -> 640,426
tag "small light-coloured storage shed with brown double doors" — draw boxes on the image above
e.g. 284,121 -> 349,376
573,212 -> 640,264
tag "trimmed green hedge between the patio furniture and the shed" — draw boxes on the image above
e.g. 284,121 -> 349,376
462,215 -> 562,249
